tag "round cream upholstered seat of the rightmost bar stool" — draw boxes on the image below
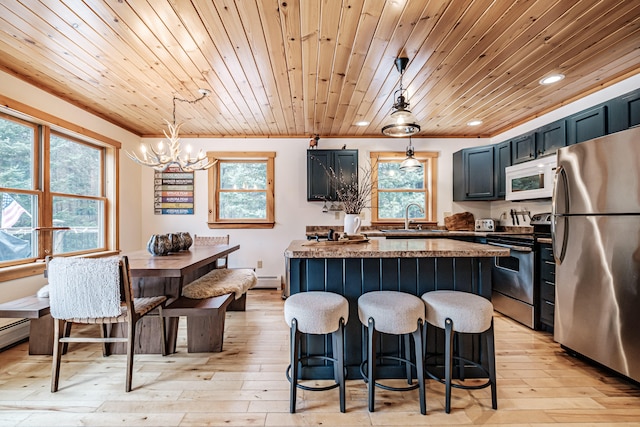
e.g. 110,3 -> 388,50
422,291 -> 493,334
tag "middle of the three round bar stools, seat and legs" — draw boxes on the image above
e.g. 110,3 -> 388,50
358,291 -> 427,415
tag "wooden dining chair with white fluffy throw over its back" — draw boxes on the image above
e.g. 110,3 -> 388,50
46,256 -> 167,393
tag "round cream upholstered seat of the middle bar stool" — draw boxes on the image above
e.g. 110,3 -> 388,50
358,291 -> 424,335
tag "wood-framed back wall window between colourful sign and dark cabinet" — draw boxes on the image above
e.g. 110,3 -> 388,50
207,152 -> 275,228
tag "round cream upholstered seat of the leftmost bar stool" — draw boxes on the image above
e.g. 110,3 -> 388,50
284,291 -> 349,334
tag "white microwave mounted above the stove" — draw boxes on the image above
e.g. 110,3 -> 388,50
505,154 -> 558,200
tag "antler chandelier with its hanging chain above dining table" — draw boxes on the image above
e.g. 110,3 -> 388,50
125,89 -> 217,172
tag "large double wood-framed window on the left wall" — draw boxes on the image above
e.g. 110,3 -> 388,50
0,108 -> 116,274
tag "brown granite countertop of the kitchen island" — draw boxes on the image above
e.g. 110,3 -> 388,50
284,238 -> 510,258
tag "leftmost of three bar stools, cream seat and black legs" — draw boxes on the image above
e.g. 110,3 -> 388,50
284,291 -> 349,414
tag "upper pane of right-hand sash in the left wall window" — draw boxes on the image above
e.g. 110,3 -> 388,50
50,134 -> 101,196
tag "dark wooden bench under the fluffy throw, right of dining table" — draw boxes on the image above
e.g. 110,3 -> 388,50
162,294 -> 235,353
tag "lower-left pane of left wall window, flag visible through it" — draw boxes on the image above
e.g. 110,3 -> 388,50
0,193 -> 37,261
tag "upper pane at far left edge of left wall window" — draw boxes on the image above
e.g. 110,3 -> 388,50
0,118 -> 35,190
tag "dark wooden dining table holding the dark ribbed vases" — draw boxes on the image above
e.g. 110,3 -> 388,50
111,244 -> 240,354
